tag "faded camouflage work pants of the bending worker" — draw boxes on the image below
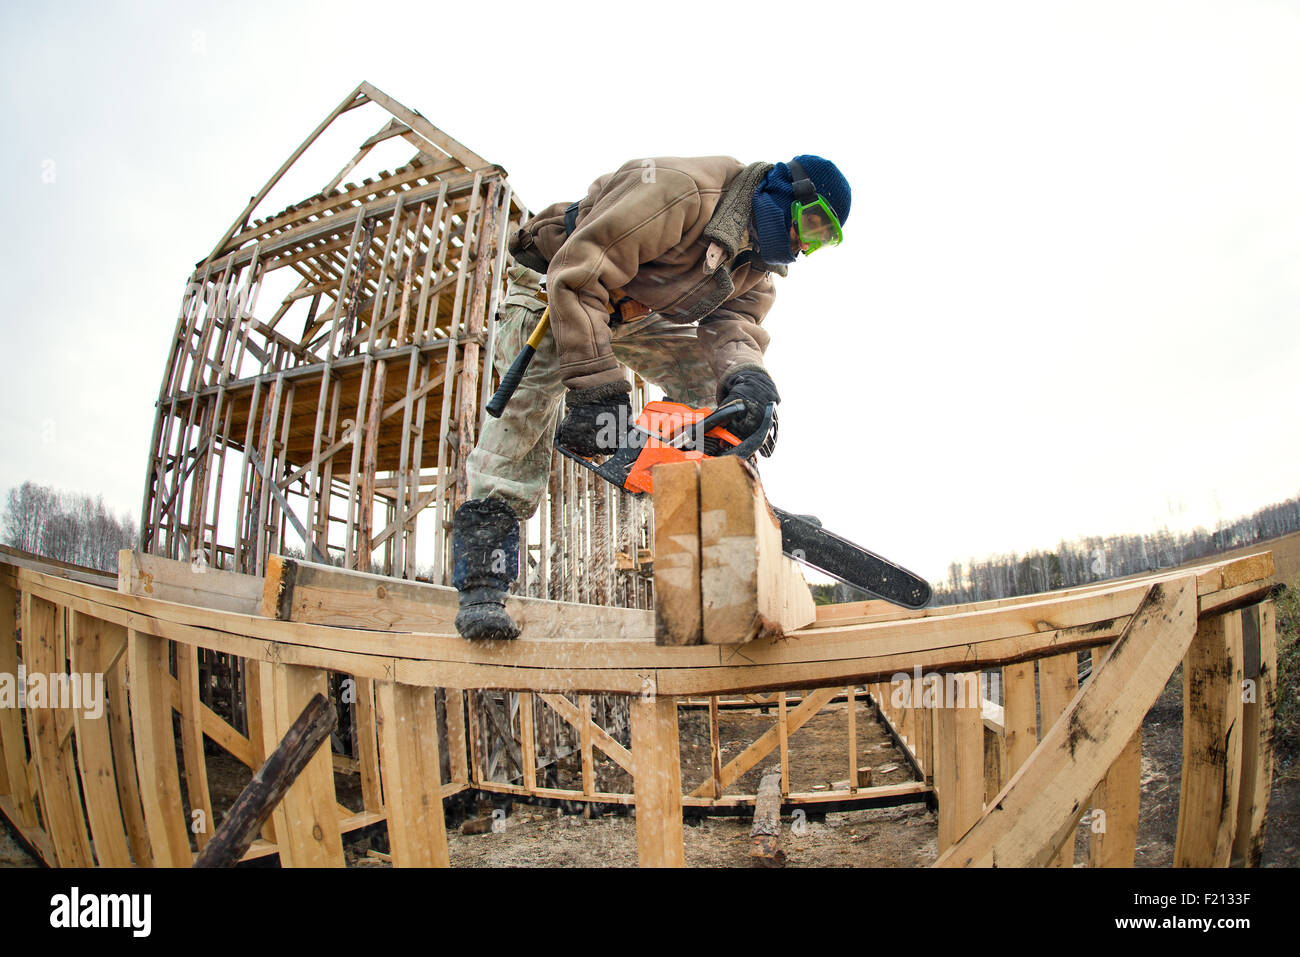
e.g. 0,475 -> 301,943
467,267 -> 718,518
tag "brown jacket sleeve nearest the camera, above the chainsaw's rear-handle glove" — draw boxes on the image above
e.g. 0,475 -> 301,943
546,163 -> 701,391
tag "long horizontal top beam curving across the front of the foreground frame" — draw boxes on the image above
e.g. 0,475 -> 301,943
16,548 -> 1271,696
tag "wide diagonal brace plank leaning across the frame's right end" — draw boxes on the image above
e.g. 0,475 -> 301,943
936,576 -> 1196,867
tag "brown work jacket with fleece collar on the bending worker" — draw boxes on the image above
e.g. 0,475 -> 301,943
510,156 -> 785,389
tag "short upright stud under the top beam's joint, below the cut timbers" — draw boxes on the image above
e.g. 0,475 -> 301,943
628,697 -> 686,867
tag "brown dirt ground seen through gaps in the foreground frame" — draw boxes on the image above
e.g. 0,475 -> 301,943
0,672 -> 1300,867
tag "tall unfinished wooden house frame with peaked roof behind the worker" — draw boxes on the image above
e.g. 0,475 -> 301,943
140,83 -> 649,606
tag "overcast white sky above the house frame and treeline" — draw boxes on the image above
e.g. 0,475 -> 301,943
0,0 -> 1300,579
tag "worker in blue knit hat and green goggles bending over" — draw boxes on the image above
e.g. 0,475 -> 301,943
452,155 -> 850,640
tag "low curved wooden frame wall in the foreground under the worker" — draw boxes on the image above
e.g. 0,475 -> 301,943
0,553 -> 1275,866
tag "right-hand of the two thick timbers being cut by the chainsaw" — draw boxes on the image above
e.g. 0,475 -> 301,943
699,455 -> 816,645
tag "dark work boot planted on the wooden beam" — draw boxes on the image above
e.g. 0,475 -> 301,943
451,498 -> 519,641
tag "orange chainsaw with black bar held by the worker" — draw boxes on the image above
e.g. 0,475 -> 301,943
555,399 -> 931,609
